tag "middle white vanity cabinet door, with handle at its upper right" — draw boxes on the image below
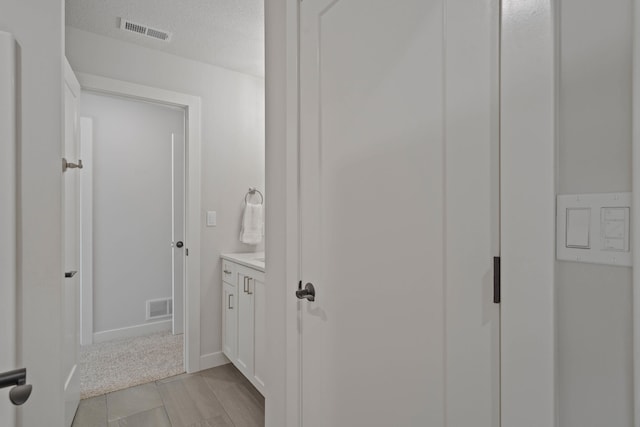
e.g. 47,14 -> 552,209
236,272 -> 254,378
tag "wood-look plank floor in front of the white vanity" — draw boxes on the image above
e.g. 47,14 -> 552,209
72,364 -> 264,427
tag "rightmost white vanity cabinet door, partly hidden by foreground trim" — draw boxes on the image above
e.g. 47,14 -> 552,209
249,274 -> 267,394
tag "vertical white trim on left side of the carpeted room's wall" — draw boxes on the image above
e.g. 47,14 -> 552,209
79,117 -> 93,345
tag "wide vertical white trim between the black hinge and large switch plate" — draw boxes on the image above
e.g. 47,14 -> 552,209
500,0 -> 556,427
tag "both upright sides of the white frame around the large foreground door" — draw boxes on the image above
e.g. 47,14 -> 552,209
265,0 -> 556,427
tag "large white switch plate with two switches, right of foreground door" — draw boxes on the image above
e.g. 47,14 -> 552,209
556,193 -> 632,267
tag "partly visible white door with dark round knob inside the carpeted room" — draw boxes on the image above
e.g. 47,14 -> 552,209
171,133 -> 186,335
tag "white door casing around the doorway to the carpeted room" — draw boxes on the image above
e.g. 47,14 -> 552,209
76,73 -> 201,373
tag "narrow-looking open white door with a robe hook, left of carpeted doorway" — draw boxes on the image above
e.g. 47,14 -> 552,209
62,62 -> 82,426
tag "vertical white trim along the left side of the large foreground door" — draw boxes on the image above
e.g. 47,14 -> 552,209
265,0 -> 301,427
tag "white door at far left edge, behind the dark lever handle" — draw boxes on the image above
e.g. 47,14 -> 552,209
0,31 -> 21,427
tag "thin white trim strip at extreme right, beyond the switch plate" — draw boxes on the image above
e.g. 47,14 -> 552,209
631,0 -> 640,427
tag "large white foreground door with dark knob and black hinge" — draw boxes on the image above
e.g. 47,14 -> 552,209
300,0 -> 500,427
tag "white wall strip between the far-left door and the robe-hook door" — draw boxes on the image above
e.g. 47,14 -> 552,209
0,0 -> 64,427
